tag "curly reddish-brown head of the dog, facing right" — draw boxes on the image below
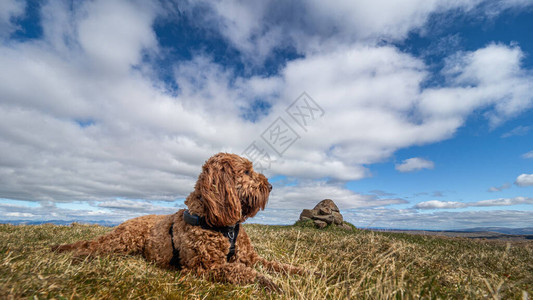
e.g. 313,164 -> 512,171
189,153 -> 272,226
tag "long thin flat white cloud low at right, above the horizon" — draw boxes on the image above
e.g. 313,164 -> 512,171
414,197 -> 533,209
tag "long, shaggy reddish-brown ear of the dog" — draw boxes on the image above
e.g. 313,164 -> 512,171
197,157 -> 242,226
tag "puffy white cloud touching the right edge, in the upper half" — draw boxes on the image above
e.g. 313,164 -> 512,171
420,44 -> 533,127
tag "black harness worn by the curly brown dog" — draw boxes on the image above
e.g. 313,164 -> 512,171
168,210 -> 240,270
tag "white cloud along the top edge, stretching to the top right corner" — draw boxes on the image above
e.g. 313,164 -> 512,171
180,0 -> 531,64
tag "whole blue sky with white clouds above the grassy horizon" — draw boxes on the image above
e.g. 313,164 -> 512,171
0,0 -> 533,229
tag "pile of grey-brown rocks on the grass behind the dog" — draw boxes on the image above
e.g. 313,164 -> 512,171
300,199 -> 352,230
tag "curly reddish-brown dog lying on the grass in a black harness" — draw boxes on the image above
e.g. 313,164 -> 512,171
52,153 -> 304,290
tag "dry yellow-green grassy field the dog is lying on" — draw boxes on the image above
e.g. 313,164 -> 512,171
0,224 -> 533,299
